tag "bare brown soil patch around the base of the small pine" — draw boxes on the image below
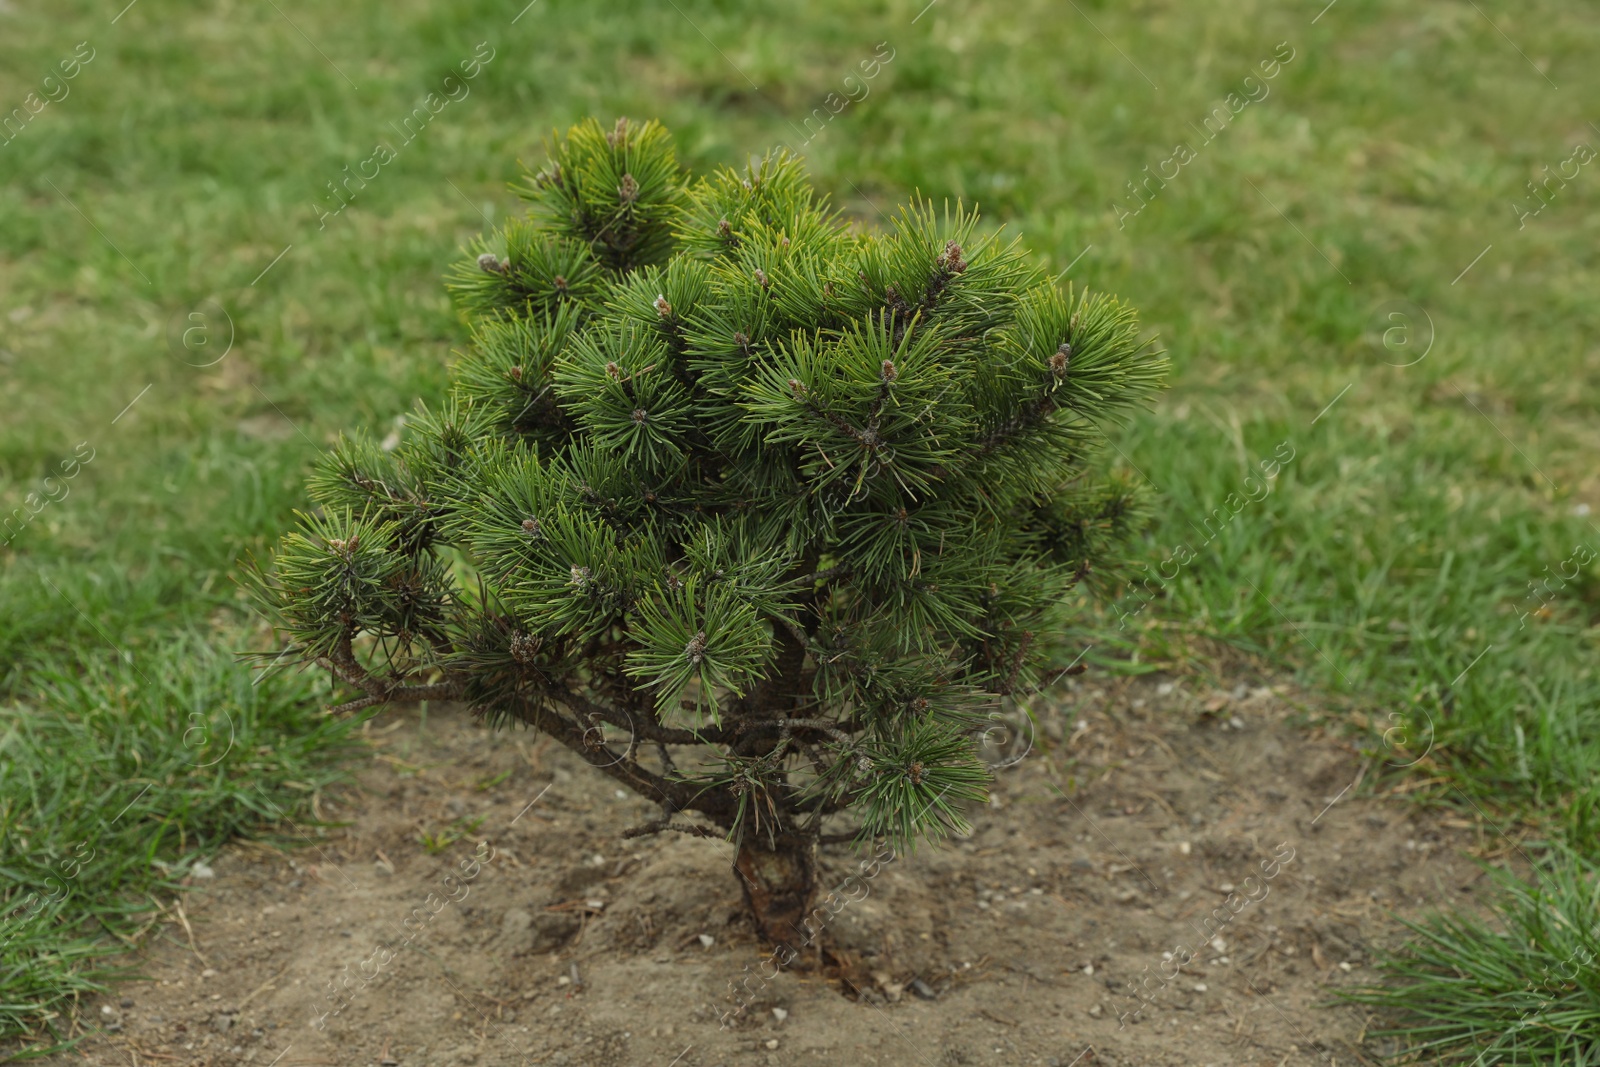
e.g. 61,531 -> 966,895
34,675 -> 1494,1067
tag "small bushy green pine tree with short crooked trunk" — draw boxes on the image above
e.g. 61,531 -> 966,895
246,120 -> 1165,945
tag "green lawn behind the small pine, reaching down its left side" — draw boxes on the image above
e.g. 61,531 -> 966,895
0,0 -> 1600,1055
